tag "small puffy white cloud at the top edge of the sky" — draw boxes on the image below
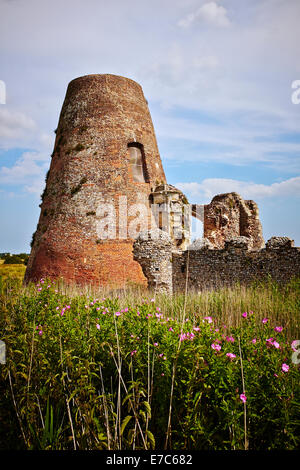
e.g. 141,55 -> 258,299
178,2 -> 230,28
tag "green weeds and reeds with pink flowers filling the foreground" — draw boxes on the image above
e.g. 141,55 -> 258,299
0,276 -> 300,450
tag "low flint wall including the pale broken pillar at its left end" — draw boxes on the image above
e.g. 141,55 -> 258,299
134,236 -> 300,293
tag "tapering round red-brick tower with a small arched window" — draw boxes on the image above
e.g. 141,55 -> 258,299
25,75 -> 166,287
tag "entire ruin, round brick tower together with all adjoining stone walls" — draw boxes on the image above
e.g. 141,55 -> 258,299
25,74 -> 300,293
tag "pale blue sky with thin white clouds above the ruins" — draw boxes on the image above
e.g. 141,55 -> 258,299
0,0 -> 300,252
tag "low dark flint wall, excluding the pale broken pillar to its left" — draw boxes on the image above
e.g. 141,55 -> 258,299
172,237 -> 300,291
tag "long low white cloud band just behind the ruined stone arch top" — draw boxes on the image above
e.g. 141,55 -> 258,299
176,176 -> 300,204
